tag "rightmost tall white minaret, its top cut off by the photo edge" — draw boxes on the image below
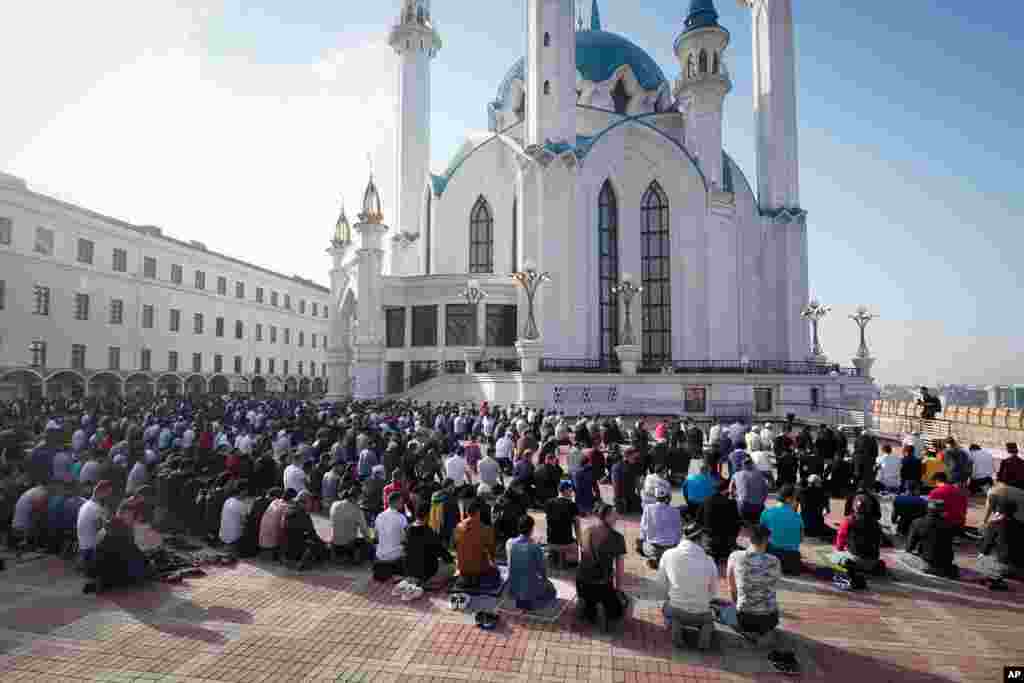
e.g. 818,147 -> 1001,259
740,0 -> 800,212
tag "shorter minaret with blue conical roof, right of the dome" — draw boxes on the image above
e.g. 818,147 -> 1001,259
675,0 -> 732,189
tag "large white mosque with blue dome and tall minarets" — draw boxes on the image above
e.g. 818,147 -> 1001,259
328,0 -> 873,415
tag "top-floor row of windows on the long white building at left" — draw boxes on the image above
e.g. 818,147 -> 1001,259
0,216 -> 328,317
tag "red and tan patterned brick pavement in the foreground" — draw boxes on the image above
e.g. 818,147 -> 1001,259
0,491 -> 1024,683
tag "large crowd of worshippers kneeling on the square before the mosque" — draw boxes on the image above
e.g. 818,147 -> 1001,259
0,397 -> 1024,647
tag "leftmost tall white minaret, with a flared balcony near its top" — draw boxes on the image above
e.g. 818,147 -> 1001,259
388,0 -> 441,245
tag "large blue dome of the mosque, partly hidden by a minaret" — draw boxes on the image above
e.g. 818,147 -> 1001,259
498,31 -> 666,109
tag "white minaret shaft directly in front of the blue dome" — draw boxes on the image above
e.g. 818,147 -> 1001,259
526,0 -> 577,146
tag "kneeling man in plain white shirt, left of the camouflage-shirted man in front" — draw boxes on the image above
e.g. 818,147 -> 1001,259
654,522 -> 718,650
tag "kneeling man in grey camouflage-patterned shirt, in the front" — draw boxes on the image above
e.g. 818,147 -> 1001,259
722,524 -> 782,638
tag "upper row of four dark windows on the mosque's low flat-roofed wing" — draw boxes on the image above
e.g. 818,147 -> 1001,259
384,303 -> 517,348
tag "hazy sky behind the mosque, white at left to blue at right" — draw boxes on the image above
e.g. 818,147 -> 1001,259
0,0 -> 1024,384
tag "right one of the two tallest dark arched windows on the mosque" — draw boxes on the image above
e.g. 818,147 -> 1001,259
640,180 -> 672,365
